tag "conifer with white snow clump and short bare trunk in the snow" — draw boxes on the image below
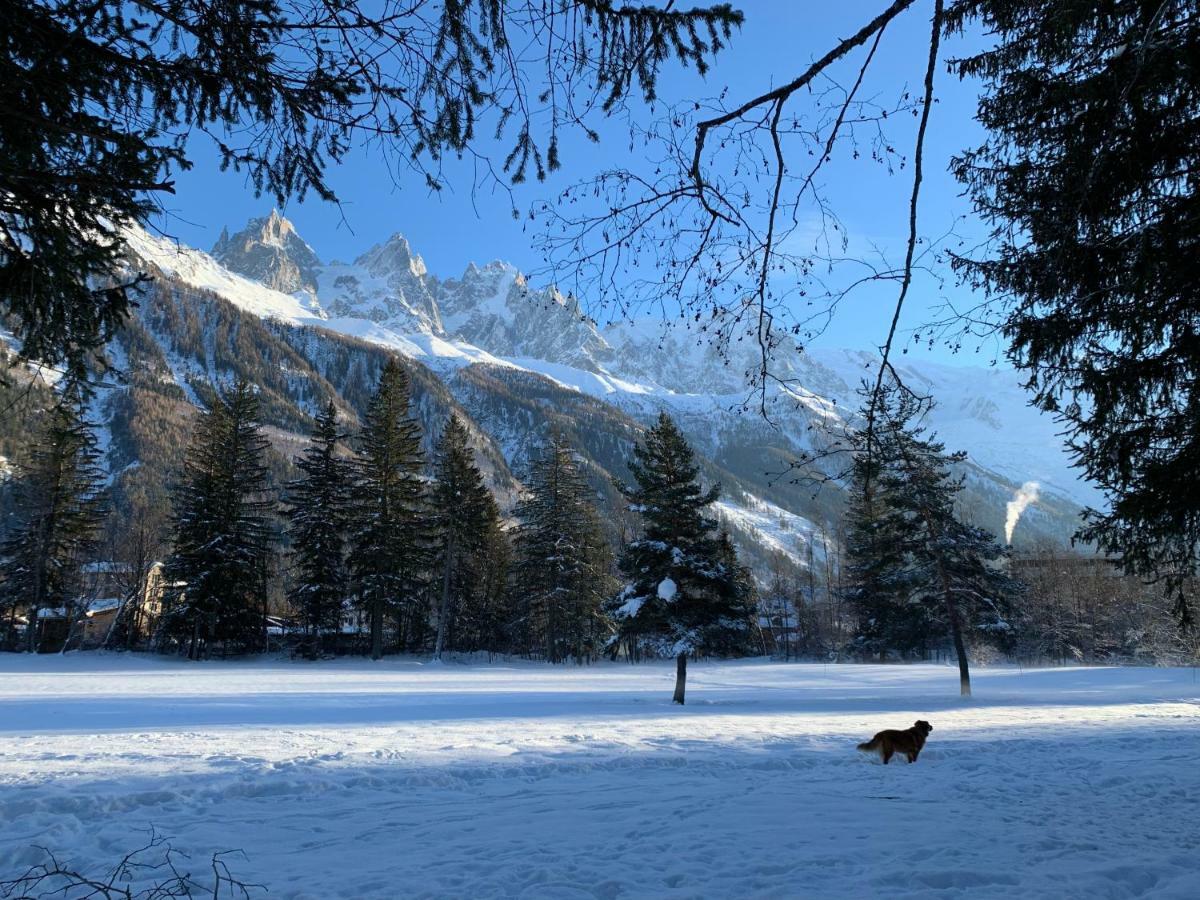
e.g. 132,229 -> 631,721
610,413 -> 754,703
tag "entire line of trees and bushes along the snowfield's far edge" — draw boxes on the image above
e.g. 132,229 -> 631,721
0,358 -> 1180,702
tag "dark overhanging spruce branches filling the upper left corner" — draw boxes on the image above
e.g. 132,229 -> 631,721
0,0 -> 742,376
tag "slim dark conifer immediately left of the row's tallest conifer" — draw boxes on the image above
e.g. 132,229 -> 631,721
287,401 -> 353,654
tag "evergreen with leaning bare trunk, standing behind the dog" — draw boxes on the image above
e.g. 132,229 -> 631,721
846,385 -> 1021,696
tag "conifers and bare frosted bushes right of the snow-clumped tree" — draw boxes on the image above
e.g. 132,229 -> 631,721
760,382 -> 1200,676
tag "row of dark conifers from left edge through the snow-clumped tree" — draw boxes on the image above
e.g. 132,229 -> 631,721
0,358 -> 755,691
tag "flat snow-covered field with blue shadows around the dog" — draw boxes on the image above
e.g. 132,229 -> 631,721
0,654 -> 1200,900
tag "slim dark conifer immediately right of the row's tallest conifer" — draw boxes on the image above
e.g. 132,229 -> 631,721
432,414 -> 500,659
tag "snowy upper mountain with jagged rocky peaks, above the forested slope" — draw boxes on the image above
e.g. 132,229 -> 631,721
132,214 -> 1098,556
